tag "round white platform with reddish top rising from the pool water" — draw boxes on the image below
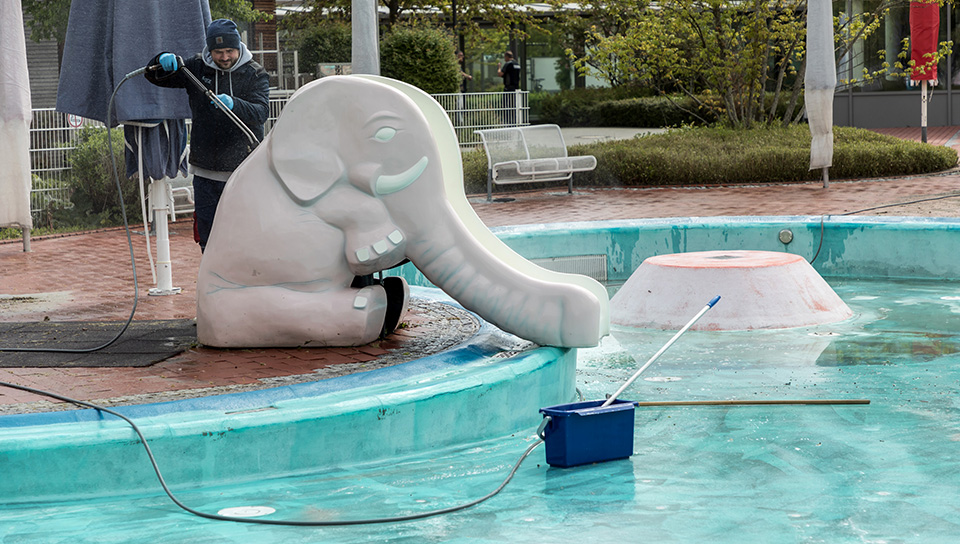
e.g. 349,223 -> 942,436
610,250 -> 853,331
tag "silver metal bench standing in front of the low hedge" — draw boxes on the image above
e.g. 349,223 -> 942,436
474,125 -> 597,202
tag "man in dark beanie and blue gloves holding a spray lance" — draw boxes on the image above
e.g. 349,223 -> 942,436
145,19 -> 270,252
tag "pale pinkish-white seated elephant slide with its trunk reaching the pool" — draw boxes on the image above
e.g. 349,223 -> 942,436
197,75 -> 609,347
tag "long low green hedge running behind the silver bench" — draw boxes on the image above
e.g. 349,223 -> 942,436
464,125 -> 957,194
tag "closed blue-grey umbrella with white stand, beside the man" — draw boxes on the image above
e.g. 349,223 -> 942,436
57,0 -> 211,294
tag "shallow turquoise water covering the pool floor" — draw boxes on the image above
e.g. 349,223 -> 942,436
0,278 -> 960,544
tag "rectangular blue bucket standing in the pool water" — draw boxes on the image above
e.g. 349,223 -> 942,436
540,399 -> 638,468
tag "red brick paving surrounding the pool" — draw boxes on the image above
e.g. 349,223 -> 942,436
0,127 -> 960,414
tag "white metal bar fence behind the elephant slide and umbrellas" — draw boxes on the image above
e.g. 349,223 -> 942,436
22,90 -> 530,218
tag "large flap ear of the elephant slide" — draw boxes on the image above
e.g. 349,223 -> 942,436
269,80 -> 346,205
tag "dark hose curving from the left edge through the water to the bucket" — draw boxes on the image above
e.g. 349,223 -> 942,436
0,381 -> 543,527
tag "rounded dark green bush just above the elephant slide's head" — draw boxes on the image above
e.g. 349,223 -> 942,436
380,25 -> 460,94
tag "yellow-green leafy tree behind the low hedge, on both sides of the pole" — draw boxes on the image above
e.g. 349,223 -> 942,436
565,0 -> 951,126
